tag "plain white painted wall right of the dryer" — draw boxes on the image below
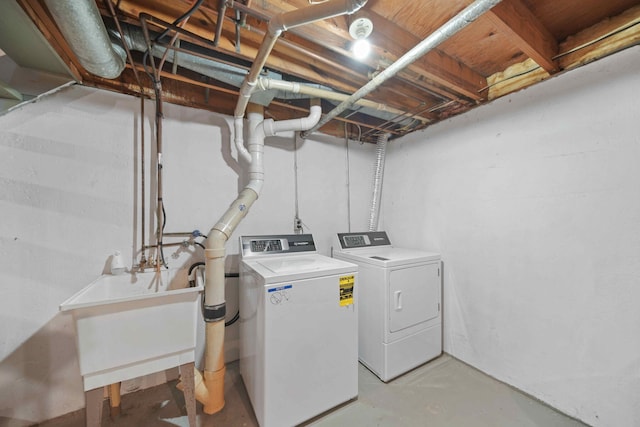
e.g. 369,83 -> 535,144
383,47 -> 640,427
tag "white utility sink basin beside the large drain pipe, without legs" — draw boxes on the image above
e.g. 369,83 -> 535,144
60,269 -> 202,391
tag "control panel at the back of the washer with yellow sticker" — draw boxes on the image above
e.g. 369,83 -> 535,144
240,234 -> 316,258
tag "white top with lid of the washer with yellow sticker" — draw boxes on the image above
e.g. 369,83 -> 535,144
243,254 -> 358,283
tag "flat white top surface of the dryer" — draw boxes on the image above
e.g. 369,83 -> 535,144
334,246 -> 440,267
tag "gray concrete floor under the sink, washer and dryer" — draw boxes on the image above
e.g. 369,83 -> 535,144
33,355 -> 586,427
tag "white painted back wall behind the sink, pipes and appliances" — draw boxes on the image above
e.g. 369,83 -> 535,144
0,87 -> 372,426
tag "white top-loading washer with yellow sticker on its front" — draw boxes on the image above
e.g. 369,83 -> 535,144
240,234 -> 358,427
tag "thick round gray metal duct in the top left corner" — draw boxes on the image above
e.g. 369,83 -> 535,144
46,0 -> 126,79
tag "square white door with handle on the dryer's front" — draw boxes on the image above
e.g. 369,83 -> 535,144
388,263 -> 440,333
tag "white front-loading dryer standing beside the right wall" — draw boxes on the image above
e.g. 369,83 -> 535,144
333,231 -> 442,382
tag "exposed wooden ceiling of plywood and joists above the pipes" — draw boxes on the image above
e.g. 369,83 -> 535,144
13,0 -> 640,142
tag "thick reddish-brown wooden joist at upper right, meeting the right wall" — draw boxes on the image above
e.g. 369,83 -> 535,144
486,0 -> 560,74
